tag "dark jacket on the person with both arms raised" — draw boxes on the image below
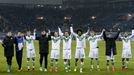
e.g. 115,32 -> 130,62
103,31 -> 120,56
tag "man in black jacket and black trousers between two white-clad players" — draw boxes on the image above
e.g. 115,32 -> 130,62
36,31 -> 51,72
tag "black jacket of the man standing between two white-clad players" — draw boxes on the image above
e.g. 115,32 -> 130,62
36,35 -> 51,54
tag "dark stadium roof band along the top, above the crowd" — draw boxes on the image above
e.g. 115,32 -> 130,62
0,0 -> 134,9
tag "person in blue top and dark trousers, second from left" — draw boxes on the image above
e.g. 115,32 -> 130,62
15,32 -> 24,71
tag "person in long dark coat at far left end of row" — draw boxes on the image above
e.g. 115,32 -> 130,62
2,32 -> 14,72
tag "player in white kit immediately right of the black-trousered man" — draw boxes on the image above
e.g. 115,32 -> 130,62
50,29 -> 61,72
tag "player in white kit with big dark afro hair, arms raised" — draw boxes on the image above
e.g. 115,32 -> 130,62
70,27 -> 88,73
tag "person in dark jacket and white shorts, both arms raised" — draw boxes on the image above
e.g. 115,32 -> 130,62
103,29 -> 120,71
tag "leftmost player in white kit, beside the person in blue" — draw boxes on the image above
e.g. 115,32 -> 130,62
25,30 -> 36,71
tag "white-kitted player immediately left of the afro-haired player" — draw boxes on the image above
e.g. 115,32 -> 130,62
59,28 -> 72,72
